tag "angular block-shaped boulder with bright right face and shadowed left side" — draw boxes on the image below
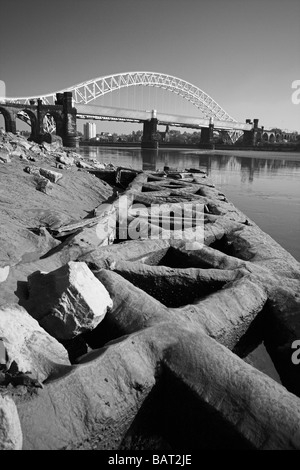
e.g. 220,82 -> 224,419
28,262 -> 112,340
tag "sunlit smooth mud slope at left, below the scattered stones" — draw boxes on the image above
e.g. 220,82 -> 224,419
0,139 -> 113,270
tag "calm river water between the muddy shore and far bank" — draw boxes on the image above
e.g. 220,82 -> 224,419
80,146 -> 300,261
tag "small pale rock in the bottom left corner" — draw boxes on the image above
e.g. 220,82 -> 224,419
0,395 -> 23,450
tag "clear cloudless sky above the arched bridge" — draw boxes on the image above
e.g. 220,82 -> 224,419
0,0 -> 300,132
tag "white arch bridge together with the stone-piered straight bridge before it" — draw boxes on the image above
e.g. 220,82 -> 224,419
0,72 -> 296,148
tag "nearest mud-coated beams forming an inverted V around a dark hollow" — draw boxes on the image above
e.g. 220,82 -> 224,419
17,322 -> 300,450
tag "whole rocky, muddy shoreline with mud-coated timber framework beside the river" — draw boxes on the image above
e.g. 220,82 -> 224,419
0,133 -> 300,450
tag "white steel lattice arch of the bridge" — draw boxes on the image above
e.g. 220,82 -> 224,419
4,72 -> 240,141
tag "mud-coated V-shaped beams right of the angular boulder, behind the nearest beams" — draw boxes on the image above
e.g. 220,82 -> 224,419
93,270 -> 267,349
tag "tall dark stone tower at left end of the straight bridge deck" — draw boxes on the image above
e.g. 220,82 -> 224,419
62,91 -> 79,147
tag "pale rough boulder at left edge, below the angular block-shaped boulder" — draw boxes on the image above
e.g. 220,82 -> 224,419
0,304 -> 70,382
